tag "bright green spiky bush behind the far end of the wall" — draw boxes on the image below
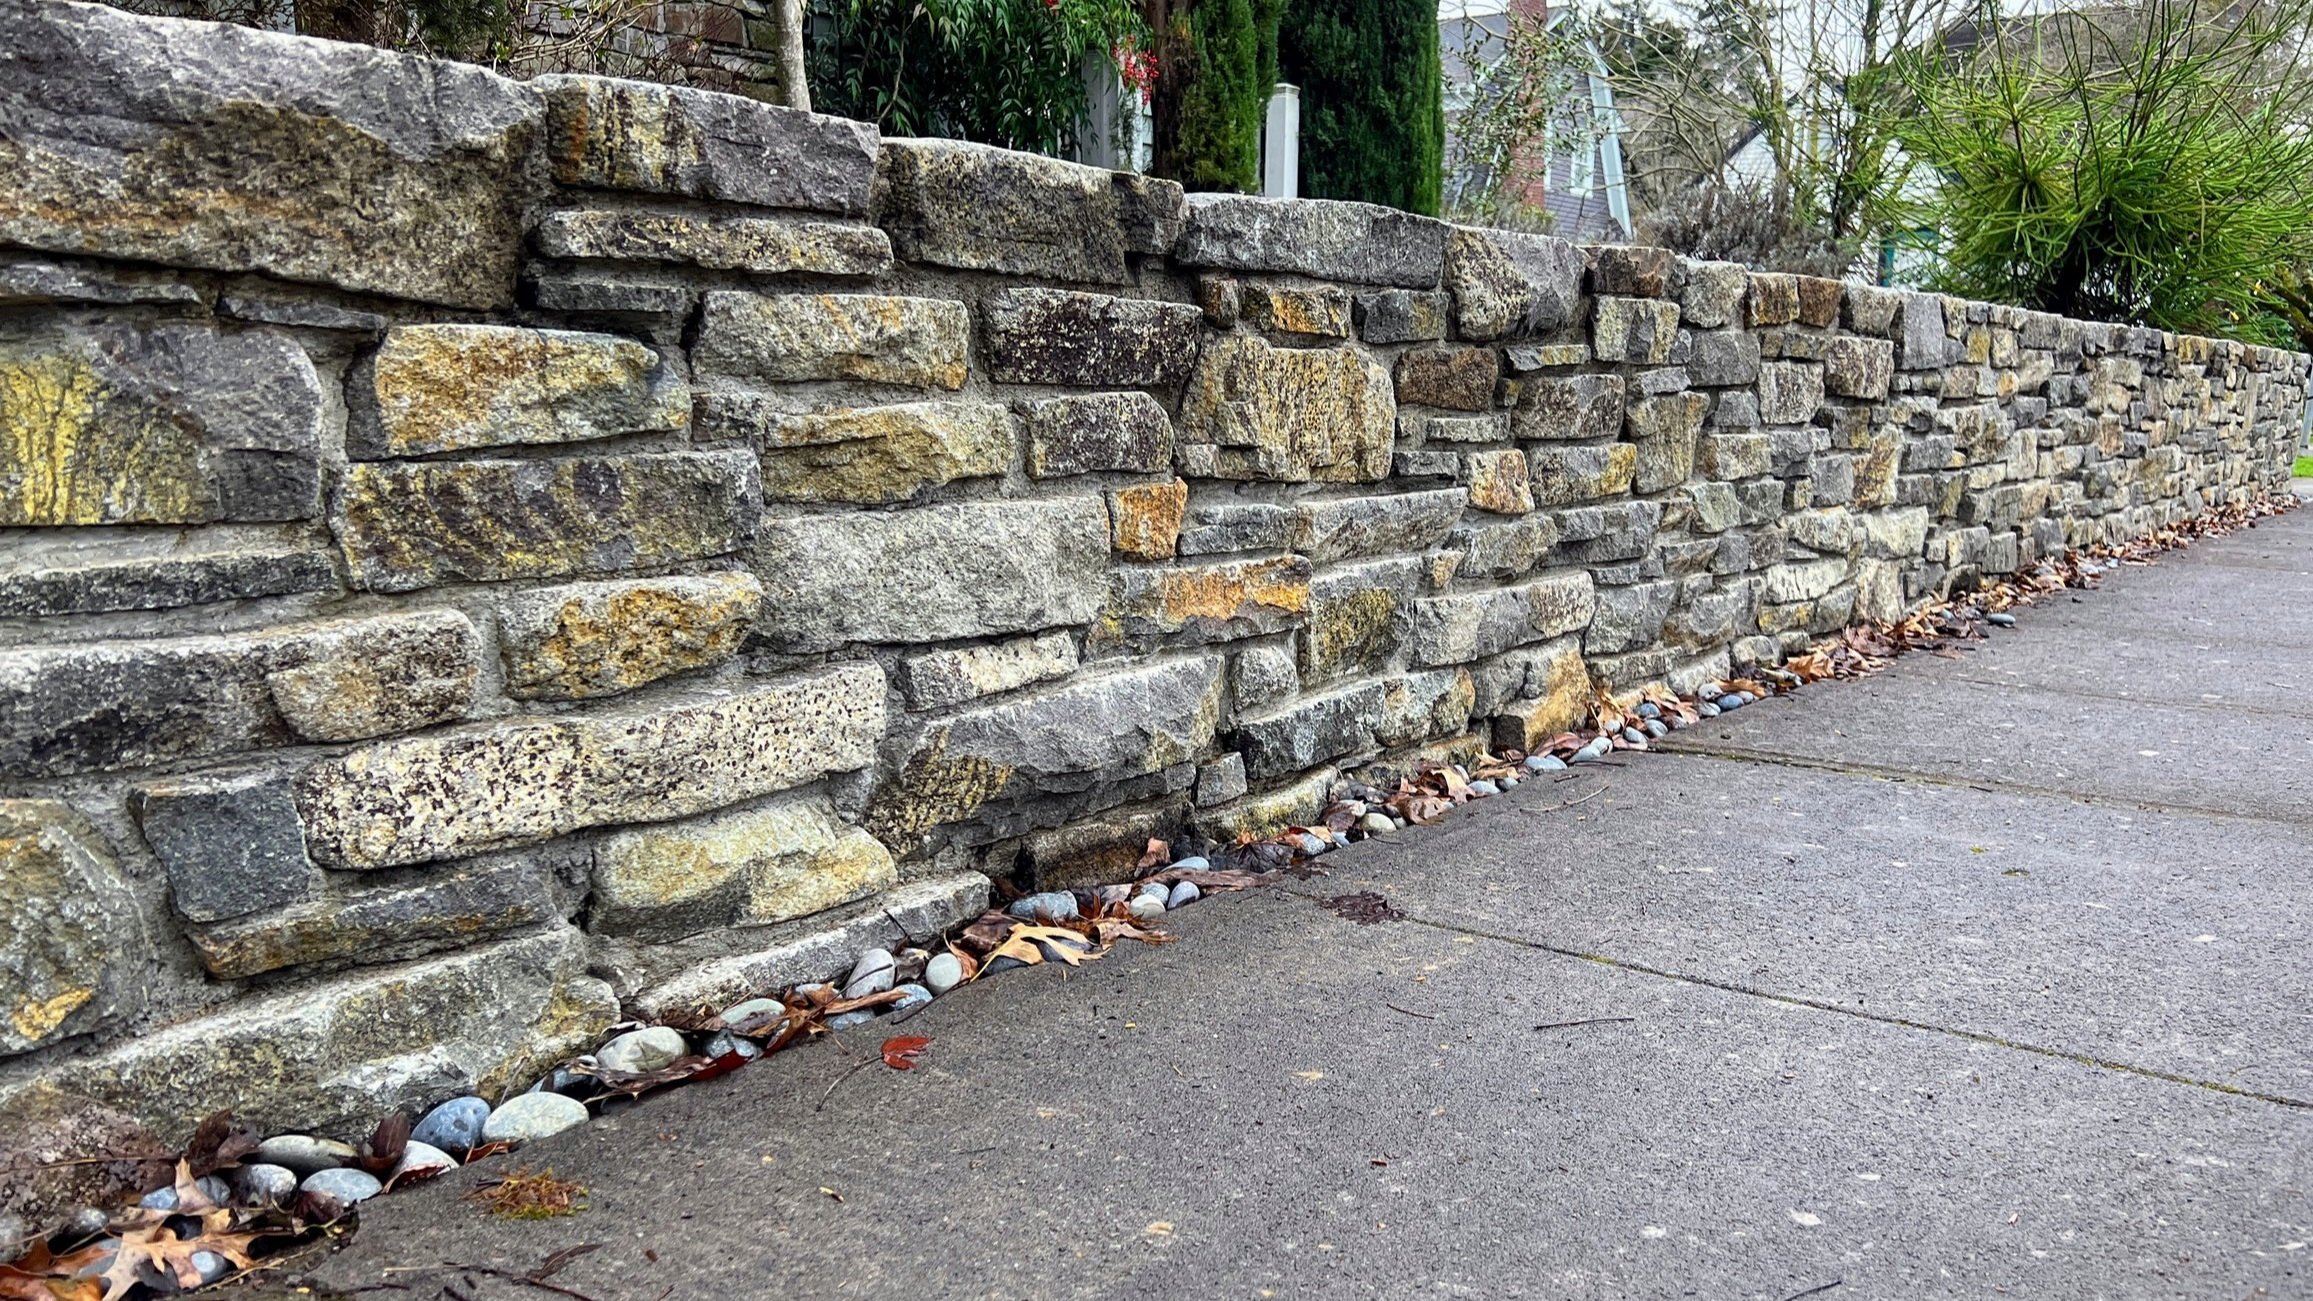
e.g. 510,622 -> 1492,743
1894,0 -> 2313,343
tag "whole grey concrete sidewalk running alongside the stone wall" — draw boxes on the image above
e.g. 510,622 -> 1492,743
310,512 -> 2313,1301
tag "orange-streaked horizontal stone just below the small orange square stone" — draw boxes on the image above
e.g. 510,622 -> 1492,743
1089,556 -> 1309,648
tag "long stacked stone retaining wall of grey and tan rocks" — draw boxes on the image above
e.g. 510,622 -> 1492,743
0,0 -> 2306,1130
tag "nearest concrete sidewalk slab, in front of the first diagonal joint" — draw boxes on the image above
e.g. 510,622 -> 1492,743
319,880 -> 2313,1301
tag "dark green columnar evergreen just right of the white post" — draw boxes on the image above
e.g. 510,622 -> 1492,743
1277,0 -> 1446,215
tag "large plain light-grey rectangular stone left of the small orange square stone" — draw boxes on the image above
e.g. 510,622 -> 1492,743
754,495 -> 1108,651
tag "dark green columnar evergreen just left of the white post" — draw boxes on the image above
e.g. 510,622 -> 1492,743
1152,0 -> 1277,192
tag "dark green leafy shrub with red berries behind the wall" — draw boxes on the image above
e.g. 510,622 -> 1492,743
805,0 -> 1145,153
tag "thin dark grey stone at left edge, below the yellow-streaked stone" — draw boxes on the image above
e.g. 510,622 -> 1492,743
0,537 -> 338,616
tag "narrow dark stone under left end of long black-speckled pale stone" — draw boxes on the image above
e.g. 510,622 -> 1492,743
185,857 -> 562,979
